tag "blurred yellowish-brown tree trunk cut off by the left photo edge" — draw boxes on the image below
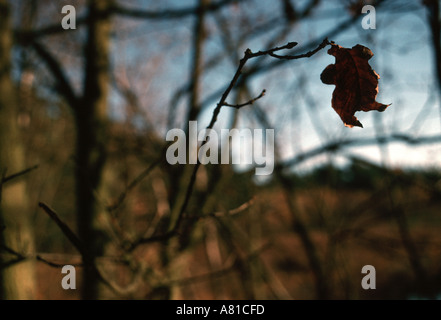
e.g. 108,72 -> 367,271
0,0 -> 36,299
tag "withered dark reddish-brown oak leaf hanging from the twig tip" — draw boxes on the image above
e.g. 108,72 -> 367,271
320,44 -> 390,128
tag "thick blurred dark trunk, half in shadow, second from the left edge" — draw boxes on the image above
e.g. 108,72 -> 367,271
74,0 -> 112,299
